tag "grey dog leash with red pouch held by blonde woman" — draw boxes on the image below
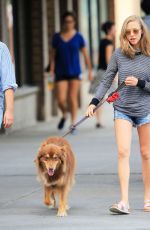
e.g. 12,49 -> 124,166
62,81 -> 125,137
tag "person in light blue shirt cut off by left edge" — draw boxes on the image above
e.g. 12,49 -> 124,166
0,42 -> 17,128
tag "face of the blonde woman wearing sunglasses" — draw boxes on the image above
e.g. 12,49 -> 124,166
126,21 -> 142,46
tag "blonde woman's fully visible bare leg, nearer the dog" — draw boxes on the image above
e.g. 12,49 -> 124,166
115,119 -> 132,205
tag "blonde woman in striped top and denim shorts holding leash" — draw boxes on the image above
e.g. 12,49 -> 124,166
86,16 -> 150,214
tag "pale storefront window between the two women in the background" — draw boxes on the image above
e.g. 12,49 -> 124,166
79,0 -> 108,67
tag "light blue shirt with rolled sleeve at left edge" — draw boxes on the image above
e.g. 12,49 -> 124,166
0,42 -> 17,110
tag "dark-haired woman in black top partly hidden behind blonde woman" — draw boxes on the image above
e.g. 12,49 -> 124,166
90,21 -> 115,128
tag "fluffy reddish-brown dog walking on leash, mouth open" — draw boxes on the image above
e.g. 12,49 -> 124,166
35,137 -> 75,216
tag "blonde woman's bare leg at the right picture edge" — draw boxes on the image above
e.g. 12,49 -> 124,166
138,123 -> 150,210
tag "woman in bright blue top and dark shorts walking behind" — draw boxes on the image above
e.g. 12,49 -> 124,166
50,12 -> 92,129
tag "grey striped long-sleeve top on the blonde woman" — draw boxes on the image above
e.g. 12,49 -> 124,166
95,48 -> 150,117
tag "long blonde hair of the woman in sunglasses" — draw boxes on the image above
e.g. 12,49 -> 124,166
120,15 -> 150,58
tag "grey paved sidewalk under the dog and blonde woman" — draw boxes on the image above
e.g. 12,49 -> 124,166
0,104 -> 150,230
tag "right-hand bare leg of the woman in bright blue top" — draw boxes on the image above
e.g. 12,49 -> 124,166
68,80 -> 80,124
